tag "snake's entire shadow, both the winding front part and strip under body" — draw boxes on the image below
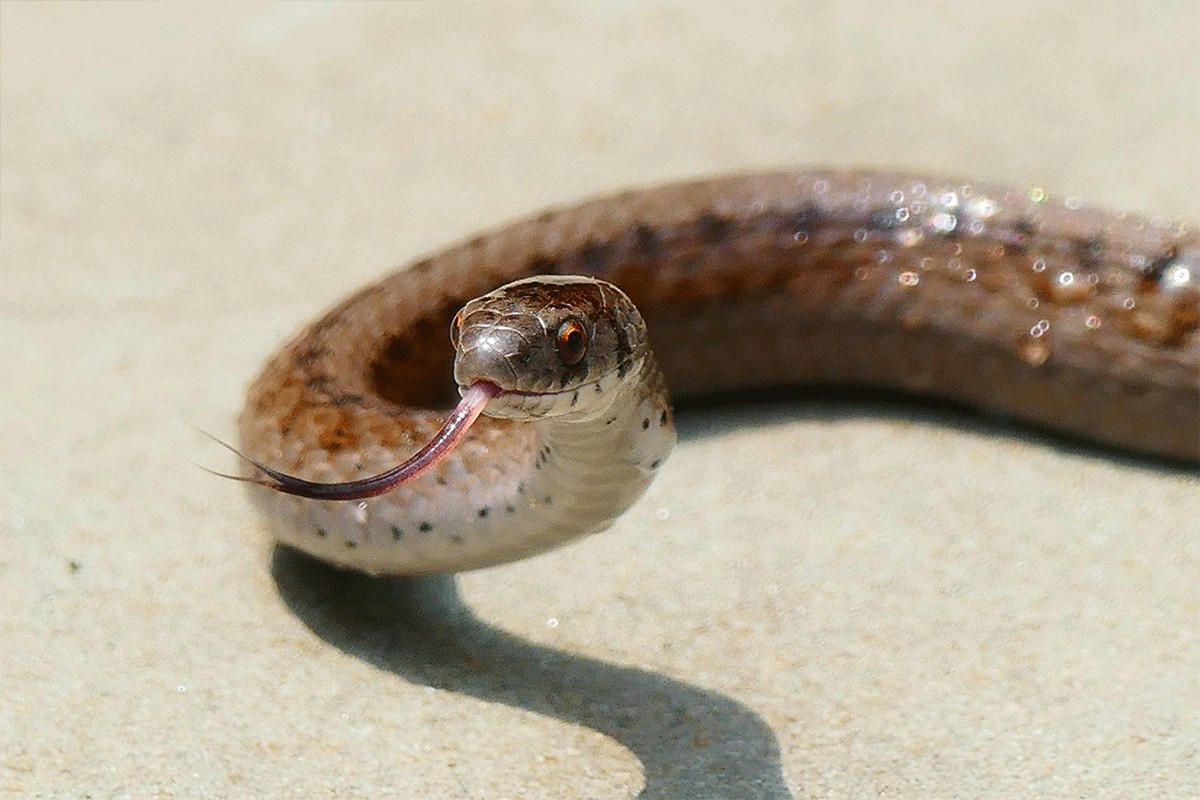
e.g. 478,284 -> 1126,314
271,390 -> 1200,800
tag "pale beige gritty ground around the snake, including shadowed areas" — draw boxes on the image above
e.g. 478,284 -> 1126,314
0,2 -> 1200,800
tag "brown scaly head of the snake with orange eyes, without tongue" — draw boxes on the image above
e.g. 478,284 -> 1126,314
450,276 -> 648,420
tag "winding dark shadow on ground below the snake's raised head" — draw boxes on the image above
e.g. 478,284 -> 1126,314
271,546 -> 792,800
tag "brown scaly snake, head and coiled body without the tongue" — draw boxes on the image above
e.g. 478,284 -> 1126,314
226,170 -> 1200,573
